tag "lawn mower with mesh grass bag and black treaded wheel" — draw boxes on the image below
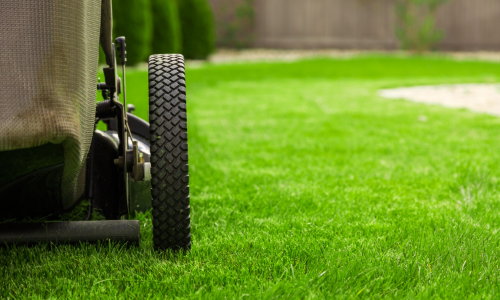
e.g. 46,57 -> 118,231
0,0 -> 191,249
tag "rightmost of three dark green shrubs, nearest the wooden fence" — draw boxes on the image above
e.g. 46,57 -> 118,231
177,0 -> 215,59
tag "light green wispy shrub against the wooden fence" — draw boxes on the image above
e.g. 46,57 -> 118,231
396,0 -> 447,53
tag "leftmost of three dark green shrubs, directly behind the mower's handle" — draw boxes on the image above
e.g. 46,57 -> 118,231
113,0 -> 153,65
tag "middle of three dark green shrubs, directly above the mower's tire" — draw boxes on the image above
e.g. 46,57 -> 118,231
151,0 -> 184,54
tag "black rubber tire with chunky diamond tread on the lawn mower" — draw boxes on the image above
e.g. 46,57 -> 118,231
149,54 -> 191,250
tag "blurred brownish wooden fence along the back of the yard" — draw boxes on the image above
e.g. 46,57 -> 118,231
210,0 -> 500,51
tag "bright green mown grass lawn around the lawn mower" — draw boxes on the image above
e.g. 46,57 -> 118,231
0,56 -> 500,299
